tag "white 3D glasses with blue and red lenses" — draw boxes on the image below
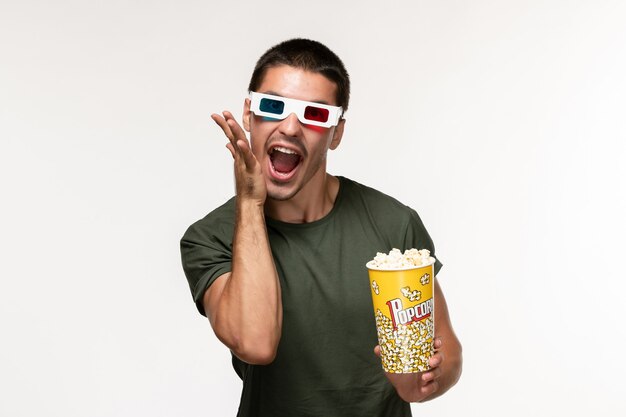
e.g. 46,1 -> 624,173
250,92 -> 343,127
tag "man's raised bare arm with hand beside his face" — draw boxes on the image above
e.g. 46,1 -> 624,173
203,112 -> 283,364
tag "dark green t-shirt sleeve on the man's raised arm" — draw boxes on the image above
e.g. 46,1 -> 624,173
180,219 -> 232,316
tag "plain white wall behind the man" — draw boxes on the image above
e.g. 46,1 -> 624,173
0,0 -> 626,417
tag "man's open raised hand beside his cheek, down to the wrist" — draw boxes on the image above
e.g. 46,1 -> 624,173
211,111 -> 267,205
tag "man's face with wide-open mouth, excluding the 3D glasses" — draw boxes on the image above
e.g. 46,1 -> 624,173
243,65 -> 344,200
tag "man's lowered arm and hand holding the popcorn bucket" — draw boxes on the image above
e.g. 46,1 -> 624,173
375,279 -> 463,402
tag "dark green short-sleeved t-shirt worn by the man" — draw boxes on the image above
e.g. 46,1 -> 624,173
181,177 -> 441,417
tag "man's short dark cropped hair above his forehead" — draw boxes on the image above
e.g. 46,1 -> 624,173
248,38 -> 350,111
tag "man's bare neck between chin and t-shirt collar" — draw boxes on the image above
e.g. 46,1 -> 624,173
265,173 -> 339,223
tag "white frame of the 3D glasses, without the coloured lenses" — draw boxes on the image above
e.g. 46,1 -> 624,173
250,91 -> 343,127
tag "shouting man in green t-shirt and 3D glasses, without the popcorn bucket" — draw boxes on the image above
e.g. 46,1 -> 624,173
181,39 -> 462,417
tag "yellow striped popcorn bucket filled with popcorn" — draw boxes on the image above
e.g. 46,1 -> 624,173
366,249 -> 435,373
